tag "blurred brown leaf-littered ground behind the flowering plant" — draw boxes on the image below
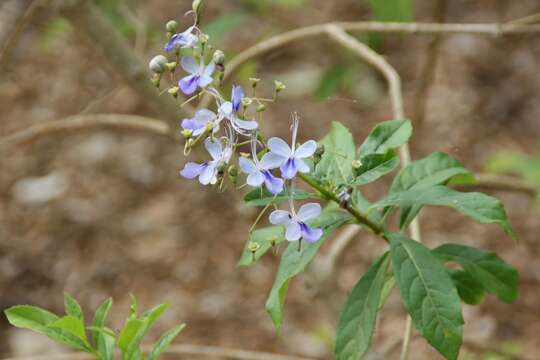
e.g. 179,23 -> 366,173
0,0 -> 540,360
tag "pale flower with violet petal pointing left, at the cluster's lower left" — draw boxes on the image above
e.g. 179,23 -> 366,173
180,138 -> 232,185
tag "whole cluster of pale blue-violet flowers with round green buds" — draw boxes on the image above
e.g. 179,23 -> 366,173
149,2 -> 322,242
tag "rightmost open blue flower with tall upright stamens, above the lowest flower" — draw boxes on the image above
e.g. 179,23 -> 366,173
261,115 -> 317,179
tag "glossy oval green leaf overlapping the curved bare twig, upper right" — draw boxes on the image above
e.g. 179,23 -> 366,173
359,120 -> 412,161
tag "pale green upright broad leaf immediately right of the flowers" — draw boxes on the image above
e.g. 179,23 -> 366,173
313,121 -> 356,185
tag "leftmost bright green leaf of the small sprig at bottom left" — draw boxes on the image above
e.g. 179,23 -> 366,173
4,305 -> 58,334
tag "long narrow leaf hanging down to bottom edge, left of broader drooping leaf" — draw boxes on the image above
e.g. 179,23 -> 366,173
335,253 -> 390,360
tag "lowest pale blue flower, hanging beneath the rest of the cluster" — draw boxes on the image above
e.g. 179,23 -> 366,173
269,203 -> 323,243
